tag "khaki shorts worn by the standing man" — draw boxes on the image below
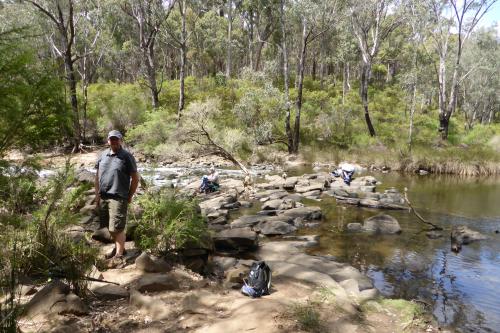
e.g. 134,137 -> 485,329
99,198 -> 128,232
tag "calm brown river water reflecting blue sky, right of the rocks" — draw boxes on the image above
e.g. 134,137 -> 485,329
302,173 -> 500,332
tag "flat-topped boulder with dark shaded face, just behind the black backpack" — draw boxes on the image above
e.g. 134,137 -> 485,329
213,228 -> 258,250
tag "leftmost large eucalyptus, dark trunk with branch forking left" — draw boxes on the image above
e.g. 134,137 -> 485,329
26,0 -> 81,151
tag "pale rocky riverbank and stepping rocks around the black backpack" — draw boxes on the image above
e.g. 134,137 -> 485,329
13,152 -> 444,333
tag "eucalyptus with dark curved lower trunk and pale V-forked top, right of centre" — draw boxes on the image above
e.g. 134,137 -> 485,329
349,0 -> 401,136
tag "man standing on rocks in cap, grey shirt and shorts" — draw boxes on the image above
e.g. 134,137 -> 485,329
95,130 -> 139,259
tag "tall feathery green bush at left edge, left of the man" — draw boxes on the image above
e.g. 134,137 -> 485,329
0,162 -> 97,294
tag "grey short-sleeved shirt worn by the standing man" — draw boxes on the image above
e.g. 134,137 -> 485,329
95,148 -> 137,199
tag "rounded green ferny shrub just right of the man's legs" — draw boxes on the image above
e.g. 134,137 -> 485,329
135,190 -> 207,255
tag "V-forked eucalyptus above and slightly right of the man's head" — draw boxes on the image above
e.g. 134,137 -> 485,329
121,0 -> 176,109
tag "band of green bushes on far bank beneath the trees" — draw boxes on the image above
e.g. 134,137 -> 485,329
84,75 -> 500,174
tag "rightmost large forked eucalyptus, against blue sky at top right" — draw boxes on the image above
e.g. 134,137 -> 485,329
425,0 -> 496,140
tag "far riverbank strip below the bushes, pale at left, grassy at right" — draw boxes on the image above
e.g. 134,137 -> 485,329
6,135 -> 500,176
